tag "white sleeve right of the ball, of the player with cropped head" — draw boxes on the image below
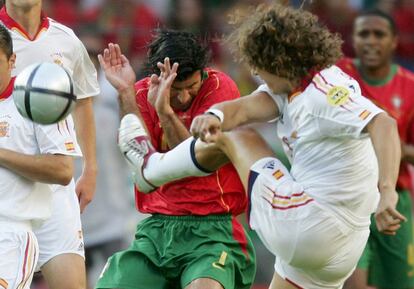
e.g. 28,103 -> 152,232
73,41 -> 100,99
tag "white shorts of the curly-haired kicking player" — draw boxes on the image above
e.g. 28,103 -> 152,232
249,158 -> 369,289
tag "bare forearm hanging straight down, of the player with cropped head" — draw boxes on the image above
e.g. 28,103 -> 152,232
74,97 -> 97,176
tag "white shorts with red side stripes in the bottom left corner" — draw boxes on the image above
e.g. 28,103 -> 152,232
0,228 -> 39,289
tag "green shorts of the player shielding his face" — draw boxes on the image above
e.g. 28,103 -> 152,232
95,215 -> 256,289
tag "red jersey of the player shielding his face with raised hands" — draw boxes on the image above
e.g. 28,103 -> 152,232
135,69 -> 247,215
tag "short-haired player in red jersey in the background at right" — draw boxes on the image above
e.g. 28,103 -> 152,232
338,10 -> 414,289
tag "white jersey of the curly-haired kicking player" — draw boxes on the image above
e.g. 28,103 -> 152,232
254,66 -> 382,224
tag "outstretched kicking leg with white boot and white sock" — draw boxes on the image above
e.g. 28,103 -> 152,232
118,114 -> 282,192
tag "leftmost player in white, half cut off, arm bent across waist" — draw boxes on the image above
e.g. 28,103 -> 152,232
0,25 -> 80,289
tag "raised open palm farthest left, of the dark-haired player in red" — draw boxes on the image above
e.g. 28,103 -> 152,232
98,43 -> 136,90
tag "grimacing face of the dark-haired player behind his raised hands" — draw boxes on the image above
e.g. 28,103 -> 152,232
170,70 -> 203,111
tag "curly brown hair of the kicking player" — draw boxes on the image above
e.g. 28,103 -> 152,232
228,4 -> 342,80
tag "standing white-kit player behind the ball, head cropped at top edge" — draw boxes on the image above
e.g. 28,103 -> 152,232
0,0 -> 99,289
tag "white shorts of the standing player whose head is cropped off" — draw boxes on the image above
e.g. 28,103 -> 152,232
34,179 -> 85,271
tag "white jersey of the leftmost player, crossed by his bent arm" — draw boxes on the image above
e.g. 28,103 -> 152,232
0,83 -> 80,222
